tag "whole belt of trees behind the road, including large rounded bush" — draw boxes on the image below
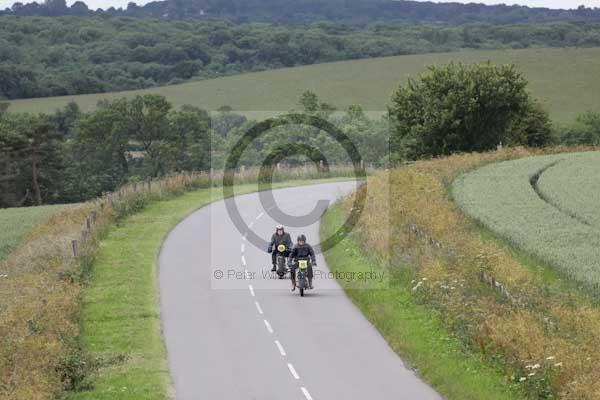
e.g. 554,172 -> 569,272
0,63 -> 600,207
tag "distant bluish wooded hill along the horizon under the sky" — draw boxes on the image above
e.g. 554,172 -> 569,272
0,0 -> 600,25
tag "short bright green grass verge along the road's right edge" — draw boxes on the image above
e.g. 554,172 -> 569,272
320,204 -> 525,400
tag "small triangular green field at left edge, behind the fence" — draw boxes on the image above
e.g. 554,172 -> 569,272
0,205 -> 70,261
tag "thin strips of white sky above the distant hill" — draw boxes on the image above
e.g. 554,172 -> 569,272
0,0 -> 600,10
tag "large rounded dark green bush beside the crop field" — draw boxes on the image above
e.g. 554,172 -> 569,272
389,62 -> 548,160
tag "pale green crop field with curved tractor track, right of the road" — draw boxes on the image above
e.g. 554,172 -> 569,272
453,152 -> 600,288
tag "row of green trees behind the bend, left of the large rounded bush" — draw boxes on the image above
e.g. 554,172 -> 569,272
0,93 -> 387,207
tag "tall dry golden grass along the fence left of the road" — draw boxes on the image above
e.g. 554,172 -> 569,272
0,167 -> 356,400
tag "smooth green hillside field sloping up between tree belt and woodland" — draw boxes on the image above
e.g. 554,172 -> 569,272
11,48 -> 600,122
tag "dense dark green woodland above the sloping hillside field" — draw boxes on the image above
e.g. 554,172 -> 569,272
0,16 -> 600,99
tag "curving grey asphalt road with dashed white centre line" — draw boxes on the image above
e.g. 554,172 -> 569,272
159,182 -> 441,400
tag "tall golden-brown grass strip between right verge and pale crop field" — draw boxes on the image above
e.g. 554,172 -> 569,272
348,149 -> 600,399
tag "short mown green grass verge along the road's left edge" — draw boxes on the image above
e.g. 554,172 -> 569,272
68,179 -> 350,400
